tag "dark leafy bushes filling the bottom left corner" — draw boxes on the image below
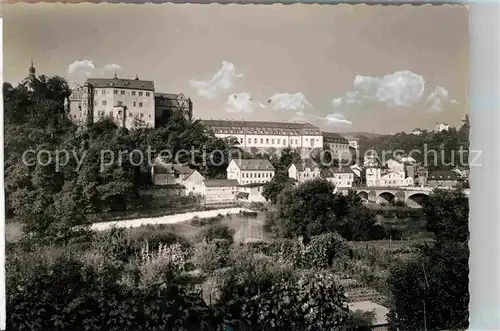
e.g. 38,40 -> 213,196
6,247 -> 213,331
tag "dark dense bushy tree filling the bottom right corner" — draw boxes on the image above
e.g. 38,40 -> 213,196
388,243 -> 469,331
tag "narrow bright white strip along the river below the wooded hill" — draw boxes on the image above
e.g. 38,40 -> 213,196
91,208 -> 250,231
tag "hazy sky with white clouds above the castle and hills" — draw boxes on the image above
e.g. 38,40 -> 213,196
2,3 -> 469,133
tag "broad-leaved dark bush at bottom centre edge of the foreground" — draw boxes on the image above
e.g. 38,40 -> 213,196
217,272 -> 349,330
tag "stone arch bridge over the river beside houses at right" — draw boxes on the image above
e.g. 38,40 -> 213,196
356,187 -> 432,208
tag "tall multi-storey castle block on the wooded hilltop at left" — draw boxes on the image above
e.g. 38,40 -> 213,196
68,74 -> 193,128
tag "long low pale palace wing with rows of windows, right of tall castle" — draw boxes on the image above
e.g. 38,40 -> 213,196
203,120 -> 349,153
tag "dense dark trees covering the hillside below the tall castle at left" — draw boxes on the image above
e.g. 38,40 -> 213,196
3,76 -> 238,241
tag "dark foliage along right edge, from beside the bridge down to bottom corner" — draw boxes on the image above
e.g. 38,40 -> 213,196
389,190 -> 469,331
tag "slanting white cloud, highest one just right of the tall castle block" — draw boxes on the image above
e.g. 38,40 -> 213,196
189,61 -> 243,99
